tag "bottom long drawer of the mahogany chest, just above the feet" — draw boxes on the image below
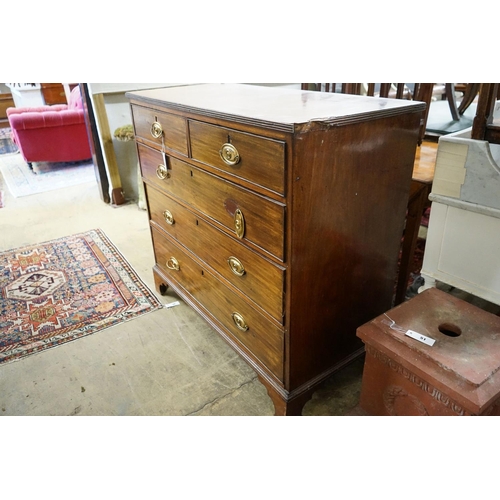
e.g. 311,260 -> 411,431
152,229 -> 284,380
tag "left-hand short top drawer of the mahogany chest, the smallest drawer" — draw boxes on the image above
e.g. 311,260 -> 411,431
132,105 -> 188,156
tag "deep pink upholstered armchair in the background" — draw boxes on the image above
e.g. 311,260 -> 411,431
7,87 -> 92,168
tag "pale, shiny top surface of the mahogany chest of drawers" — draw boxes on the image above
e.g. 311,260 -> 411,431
127,83 -> 425,132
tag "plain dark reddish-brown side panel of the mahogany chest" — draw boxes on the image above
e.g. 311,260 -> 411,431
289,114 -> 420,386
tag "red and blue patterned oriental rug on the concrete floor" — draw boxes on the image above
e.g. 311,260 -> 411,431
0,229 -> 162,364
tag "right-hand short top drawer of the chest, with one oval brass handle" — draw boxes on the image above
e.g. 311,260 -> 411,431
189,120 -> 285,196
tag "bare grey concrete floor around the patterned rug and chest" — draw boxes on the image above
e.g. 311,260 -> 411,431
0,170 -> 363,416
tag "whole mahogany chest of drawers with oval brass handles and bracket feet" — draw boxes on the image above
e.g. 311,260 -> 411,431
127,84 -> 425,415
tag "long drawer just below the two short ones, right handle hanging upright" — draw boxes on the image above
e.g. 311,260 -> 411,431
138,144 -> 285,261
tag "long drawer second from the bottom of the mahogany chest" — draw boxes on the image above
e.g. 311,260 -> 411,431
146,186 -> 285,324
